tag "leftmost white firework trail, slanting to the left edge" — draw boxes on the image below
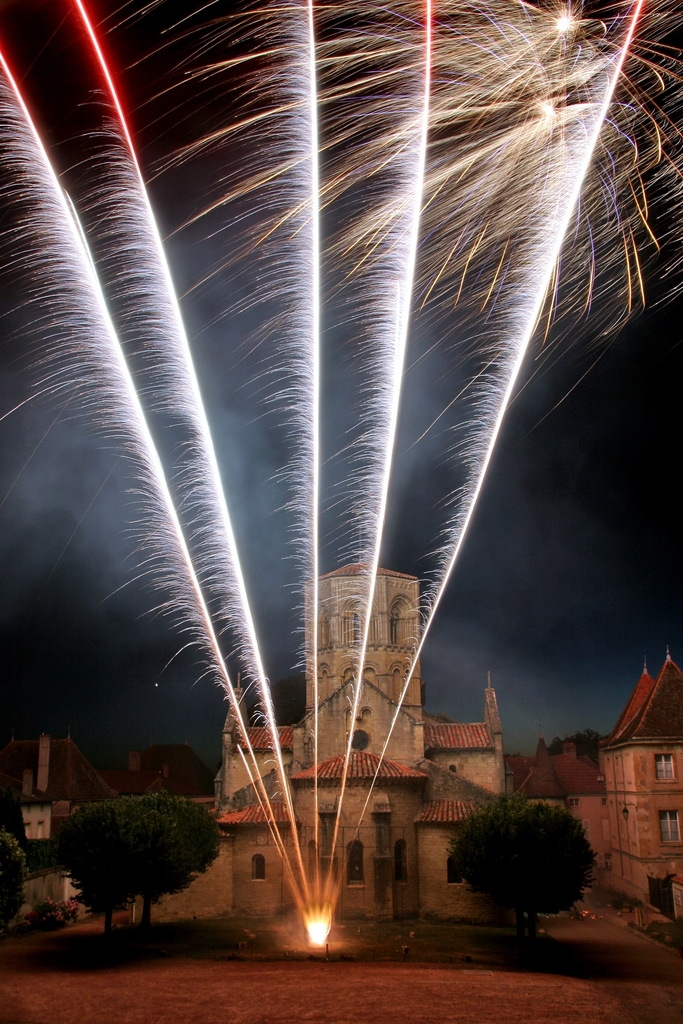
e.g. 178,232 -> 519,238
0,51 -> 301,892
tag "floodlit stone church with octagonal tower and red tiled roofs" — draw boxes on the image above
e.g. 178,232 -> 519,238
157,565 -> 505,923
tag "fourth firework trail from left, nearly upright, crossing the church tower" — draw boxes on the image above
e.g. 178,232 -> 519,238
328,0 -> 432,905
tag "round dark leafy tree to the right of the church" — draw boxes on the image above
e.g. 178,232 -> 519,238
450,794 -> 595,938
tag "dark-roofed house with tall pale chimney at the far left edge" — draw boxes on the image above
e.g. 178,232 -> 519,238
0,733 -> 116,839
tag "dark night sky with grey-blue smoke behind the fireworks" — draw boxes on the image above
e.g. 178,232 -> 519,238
0,0 -> 683,768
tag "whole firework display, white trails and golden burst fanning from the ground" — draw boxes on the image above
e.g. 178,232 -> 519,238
0,0 -> 681,929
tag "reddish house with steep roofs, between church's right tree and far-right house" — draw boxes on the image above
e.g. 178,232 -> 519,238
505,736 -> 611,879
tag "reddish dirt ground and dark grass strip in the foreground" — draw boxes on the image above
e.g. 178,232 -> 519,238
0,915 -> 683,1024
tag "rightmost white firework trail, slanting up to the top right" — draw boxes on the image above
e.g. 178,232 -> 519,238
366,0 -> 644,790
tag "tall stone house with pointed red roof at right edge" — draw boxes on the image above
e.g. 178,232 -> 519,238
600,651 -> 683,916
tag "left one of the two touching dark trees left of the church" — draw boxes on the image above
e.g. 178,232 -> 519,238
57,798 -> 139,935
